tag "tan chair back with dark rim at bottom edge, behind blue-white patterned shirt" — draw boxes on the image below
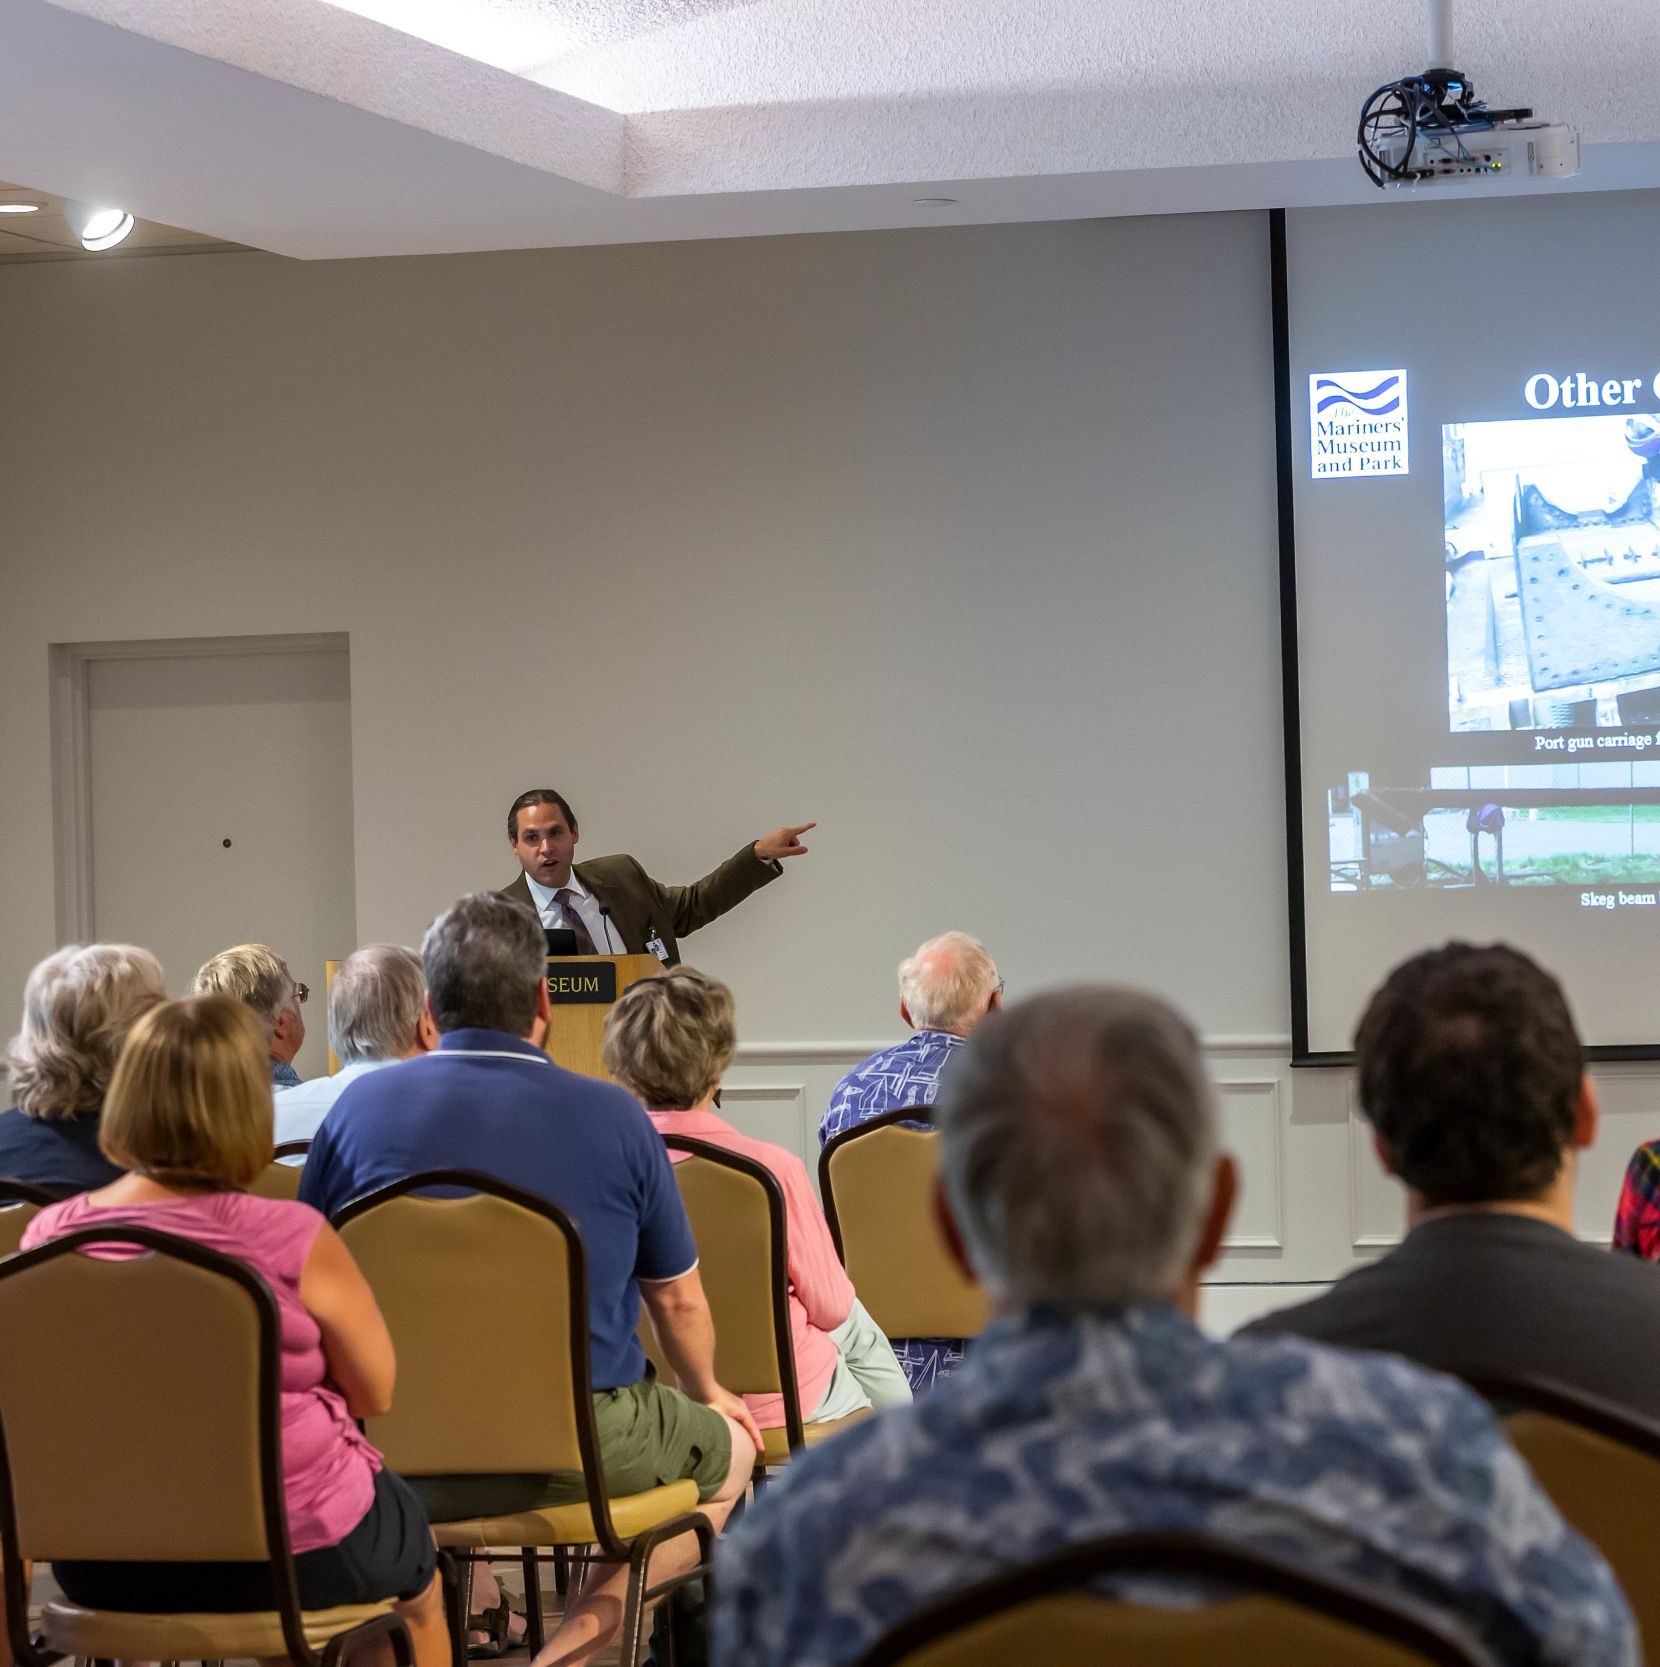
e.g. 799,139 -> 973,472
858,1534 -> 1483,1667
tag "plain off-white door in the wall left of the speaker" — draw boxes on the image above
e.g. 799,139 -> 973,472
87,636 -> 357,1077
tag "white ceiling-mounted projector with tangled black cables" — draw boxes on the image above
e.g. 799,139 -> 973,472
1355,0 -> 1580,187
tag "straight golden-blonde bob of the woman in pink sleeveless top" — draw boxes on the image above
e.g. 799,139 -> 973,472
98,995 -> 272,1189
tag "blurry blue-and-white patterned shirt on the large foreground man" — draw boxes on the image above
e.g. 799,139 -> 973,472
713,1307 -> 1640,1667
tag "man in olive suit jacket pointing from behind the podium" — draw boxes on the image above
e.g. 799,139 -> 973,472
502,787 -> 817,967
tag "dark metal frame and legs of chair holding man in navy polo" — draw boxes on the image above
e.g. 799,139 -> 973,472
335,1169 -> 715,1667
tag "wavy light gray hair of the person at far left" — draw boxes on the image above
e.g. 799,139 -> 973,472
5,944 -> 167,1119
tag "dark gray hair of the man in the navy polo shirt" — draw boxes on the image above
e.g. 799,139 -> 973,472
420,892 -> 548,1037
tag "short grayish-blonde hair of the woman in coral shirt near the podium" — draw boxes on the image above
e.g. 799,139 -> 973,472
602,967 -> 738,1112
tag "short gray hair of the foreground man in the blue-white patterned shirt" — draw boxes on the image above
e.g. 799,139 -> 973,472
935,985 -> 1217,1310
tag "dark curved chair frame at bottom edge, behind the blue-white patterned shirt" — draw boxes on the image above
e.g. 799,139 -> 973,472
857,1534 -> 1485,1667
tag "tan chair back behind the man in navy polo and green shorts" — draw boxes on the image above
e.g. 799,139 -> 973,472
335,1170 -> 592,1475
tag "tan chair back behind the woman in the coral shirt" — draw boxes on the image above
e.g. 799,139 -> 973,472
667,1137 -> 795,1395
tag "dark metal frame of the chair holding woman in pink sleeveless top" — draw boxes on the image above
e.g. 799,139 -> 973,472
0,1227 -> 415,1667
